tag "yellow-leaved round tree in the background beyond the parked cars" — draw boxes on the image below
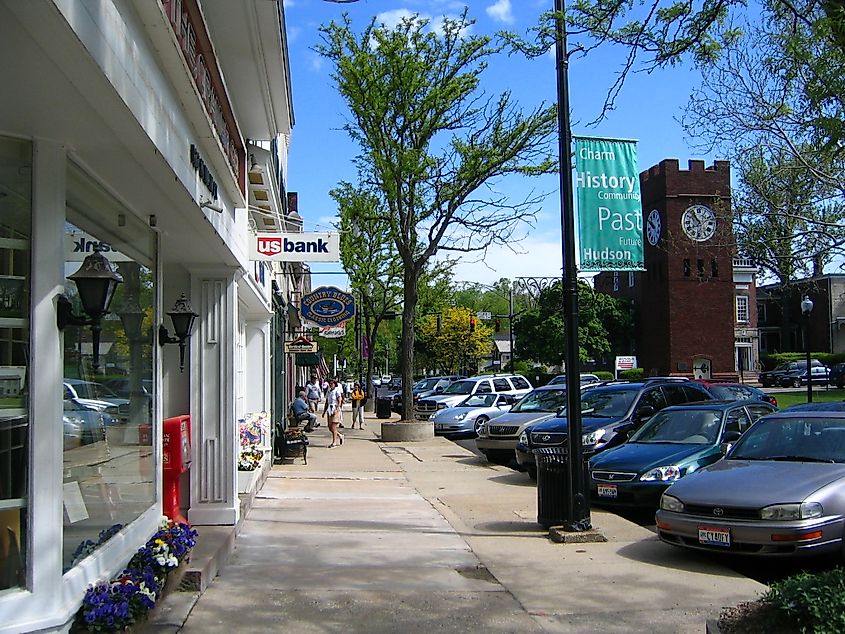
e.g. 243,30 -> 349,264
420,306 -> 493,374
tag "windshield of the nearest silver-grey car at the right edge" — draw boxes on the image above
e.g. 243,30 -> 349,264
728,415 -> 845,462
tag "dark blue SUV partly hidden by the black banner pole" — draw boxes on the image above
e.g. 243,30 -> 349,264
516,378 -> 714,470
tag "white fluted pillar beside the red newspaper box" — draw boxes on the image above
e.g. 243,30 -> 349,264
188,270 -> 240,525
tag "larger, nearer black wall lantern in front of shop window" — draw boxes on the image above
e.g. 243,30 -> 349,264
56,252 -> 123,372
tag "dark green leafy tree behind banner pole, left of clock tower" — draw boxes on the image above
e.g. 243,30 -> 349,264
516,280 -> 632,365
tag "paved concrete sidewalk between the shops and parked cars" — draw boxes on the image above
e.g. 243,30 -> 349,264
150,402 -> 764,633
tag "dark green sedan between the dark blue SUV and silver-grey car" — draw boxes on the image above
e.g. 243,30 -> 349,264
590,400 -> 776,509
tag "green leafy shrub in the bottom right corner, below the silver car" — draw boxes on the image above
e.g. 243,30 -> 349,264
763,568 -> 845,634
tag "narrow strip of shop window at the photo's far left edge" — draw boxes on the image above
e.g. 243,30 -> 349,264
0,137 -> 32,590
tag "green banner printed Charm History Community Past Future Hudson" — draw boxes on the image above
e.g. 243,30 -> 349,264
575,137 -> 645,272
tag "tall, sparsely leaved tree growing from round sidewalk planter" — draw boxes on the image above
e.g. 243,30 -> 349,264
317,11 -> 556,418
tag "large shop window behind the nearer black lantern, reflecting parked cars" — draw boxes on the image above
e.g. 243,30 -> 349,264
62,163 -> 156,570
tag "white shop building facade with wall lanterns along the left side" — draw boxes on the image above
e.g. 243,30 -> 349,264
0,0 -> 293,632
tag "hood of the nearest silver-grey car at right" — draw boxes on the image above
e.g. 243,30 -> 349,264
666,460 -> 845,508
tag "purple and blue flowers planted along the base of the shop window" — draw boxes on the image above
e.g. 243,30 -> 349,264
76,517 -> 197,632
